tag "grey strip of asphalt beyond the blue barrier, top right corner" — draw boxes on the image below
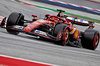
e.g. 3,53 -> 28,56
59,0 -> 100,9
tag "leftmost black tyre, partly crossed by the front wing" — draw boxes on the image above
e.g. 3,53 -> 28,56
6,12 -> 24,35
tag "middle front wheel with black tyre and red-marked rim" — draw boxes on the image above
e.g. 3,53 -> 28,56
54,24 -> 69,46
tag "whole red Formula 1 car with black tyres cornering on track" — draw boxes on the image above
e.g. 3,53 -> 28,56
0,10 -> 99,50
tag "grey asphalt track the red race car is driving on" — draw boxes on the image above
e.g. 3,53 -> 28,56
0,0 -> 100,66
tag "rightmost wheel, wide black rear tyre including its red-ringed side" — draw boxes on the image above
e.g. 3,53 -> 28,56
82,29 -> 99,50
